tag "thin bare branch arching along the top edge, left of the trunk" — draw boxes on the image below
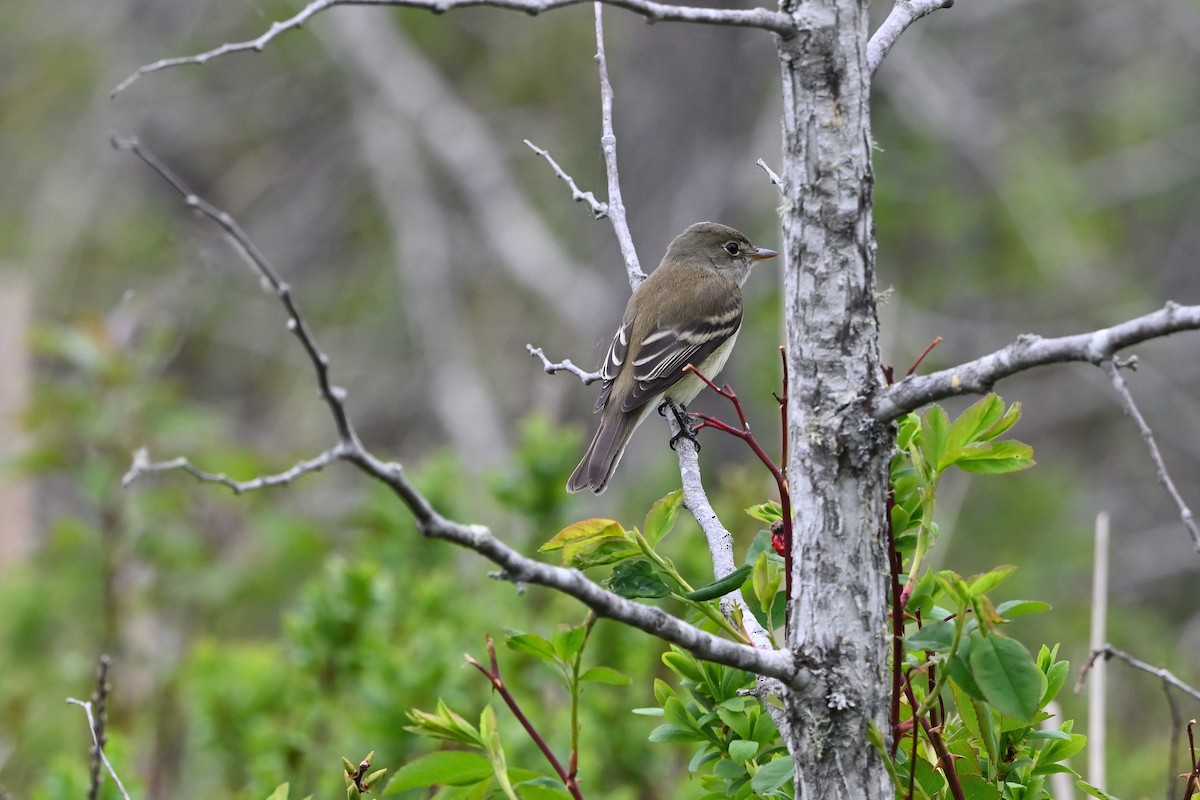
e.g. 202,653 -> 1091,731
110,0 -> 803,97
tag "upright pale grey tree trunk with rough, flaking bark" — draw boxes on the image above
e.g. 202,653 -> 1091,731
779,0 -> 893,800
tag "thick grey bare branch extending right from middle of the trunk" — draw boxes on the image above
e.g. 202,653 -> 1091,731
871,302 -> 1200,422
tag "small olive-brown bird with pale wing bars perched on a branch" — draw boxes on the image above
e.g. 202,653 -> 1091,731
566,222 -> 778,494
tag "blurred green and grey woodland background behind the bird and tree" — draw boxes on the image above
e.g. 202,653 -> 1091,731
0,0 -> 1200,799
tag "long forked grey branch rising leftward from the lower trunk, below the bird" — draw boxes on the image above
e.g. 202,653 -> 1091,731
119,139 -> 796,681
